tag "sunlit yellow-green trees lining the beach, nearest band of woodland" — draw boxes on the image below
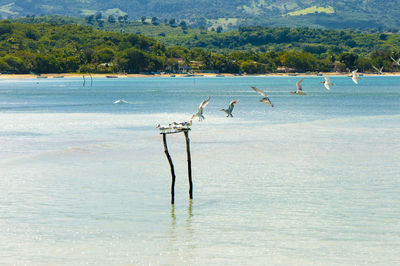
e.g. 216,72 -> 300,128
0,20 -> 400,74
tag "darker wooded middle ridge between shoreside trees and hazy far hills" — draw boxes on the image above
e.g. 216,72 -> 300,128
13,16 -> 400,58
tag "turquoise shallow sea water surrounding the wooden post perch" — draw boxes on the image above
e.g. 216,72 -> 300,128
0,77 -> 400,265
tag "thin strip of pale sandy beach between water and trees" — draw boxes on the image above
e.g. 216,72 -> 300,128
0,72 -> 400,80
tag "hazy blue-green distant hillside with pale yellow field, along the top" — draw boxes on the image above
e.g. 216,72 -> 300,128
0,0 -> 400,29
